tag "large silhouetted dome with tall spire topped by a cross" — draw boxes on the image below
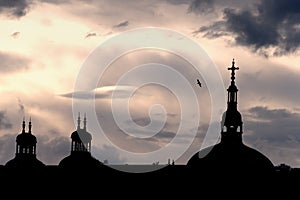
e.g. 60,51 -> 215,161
187,60 -> 274,173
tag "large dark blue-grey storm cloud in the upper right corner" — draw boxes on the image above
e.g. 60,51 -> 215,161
199,0 -> 300,56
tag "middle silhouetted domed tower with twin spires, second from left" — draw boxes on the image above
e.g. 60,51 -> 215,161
59,113 -> 102,168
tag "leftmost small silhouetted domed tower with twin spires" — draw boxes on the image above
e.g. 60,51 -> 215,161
5,119 -> 45,168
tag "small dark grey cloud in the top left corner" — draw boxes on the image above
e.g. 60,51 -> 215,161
0,0 -> 32,18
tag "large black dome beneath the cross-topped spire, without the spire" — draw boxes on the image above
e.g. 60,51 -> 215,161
187,143 -> 274,172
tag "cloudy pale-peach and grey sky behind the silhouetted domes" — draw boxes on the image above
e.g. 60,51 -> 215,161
0,0 -> 300,167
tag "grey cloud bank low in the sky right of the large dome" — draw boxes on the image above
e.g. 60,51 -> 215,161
244,106 -> 300,167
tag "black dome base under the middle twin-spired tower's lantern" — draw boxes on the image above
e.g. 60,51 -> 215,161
59,151 -> 102,168
